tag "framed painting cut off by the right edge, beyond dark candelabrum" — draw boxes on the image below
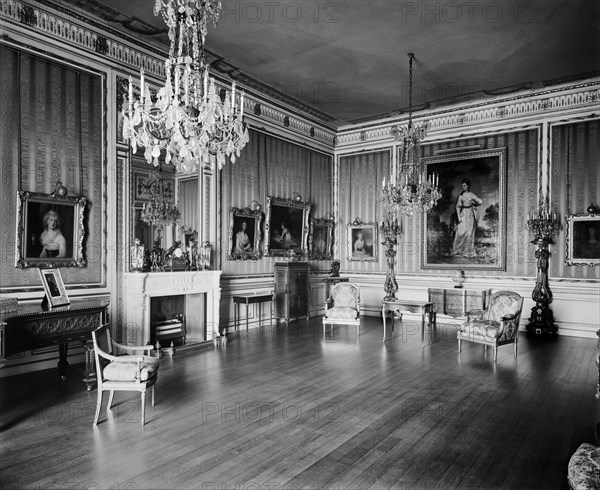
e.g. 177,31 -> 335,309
565,214 -> 600,267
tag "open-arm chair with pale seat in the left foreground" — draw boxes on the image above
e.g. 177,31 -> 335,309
92,325 -> 159,425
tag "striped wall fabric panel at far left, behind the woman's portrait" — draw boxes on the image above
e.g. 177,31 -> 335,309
0,44 -> 105,288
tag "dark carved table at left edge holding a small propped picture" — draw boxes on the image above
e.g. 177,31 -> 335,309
0,298 -> 108,390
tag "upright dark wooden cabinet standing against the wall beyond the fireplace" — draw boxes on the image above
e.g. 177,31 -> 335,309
274,262 -> 310,323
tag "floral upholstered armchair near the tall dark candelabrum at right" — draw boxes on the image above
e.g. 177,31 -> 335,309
457,291 -> 523,362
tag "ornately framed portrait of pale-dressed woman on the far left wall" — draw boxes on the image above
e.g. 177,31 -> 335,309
15,191 -> 87,268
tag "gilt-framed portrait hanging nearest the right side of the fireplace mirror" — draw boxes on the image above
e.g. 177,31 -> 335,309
228,208 -> 263,260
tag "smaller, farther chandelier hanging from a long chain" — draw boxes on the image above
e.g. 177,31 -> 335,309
381,53 -> 442,219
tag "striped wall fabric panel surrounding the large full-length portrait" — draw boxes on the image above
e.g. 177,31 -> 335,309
339,129 -> 539,276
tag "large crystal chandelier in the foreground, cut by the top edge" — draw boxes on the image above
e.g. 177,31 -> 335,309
123,0 -> 248,172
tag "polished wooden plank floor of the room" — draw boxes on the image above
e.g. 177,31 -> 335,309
0,317 -> 600,490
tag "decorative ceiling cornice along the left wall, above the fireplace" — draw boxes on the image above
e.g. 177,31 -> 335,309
0,0 -> 336,150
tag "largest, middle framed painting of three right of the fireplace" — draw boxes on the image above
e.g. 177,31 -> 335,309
265,196 -> 310,257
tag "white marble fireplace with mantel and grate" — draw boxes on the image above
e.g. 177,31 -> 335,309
125,271 -> 221,345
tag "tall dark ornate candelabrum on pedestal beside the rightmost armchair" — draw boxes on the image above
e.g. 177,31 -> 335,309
526,203 -> 559,335
